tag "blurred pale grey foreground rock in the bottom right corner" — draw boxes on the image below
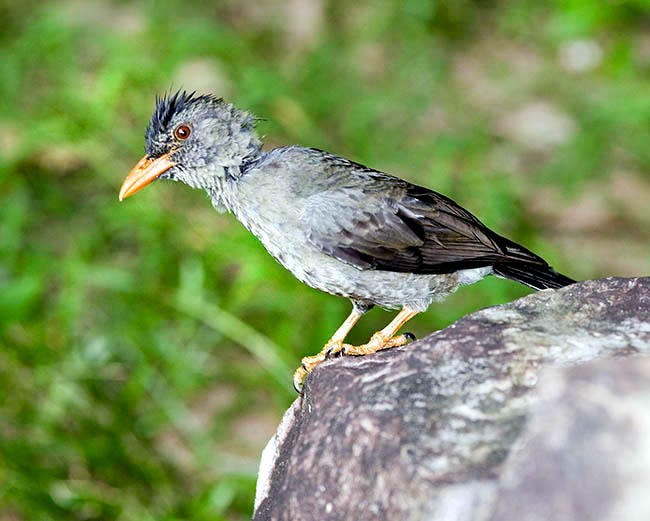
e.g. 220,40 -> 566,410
490,358 -> 650,521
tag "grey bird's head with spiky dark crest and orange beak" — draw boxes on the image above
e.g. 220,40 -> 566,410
119,91 -> 261,201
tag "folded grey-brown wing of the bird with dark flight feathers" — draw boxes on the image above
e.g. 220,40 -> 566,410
305,169 -> 546,274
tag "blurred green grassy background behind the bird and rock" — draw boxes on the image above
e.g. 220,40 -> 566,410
0,0 -> 650,521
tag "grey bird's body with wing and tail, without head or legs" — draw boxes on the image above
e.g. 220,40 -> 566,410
224,147 -> 569,307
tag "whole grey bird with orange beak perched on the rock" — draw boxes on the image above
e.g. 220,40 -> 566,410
119,90 -> 575,392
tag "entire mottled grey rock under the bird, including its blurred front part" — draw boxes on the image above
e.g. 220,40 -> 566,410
254,277 -> 650,521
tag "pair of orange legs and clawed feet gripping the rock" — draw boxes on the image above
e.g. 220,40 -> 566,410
293,307 -> 418,392
